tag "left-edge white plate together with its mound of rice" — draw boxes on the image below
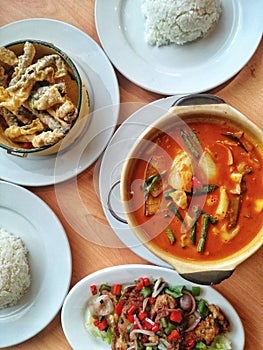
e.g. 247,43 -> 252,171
0,181 -> 71,348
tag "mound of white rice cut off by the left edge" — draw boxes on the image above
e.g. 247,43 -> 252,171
0,228 -> 31,309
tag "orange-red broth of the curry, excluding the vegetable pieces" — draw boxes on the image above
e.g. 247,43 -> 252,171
129,122 -> 263,261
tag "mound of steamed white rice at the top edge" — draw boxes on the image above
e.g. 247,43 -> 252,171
142,0 -> 222,46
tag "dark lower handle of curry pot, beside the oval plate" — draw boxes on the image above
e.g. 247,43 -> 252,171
180,270 -> 234,286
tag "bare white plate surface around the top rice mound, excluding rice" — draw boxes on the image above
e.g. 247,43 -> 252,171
95,0 -> 262,95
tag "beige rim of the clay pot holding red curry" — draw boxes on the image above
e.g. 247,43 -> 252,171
120,103 -> 263,273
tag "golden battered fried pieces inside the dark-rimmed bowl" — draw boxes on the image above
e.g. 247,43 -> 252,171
0,42 -> 78,149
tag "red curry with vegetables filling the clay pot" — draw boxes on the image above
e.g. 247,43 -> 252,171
128,119 -> 263,261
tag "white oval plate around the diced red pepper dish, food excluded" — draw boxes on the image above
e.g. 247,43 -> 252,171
61,265 -> 245,350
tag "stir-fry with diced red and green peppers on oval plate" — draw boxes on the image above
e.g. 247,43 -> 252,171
87,277 -> 232,350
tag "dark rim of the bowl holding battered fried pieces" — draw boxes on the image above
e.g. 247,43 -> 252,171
0,39 -> 82,156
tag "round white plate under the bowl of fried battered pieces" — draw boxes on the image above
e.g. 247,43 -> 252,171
0,18 -> 119,186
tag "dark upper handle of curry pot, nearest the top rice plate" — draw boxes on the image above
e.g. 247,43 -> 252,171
171,94 -> 225,107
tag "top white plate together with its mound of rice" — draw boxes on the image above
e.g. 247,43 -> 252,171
95,0 -> 262,95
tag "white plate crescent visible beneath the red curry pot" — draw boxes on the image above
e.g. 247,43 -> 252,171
99,96 -> 182,267
